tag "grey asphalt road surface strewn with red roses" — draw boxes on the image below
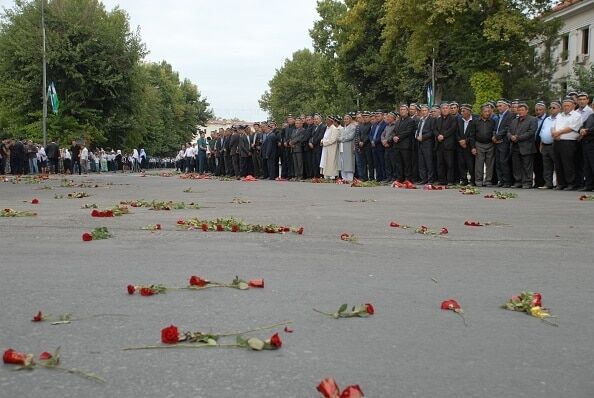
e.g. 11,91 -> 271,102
0,174 -> 594,398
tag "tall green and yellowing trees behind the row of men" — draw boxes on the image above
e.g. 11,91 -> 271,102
263,0 -> 559,118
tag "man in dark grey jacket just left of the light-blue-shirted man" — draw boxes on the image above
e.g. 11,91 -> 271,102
507,102 -> 538,189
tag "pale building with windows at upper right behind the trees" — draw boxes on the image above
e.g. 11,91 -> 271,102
544,0 -> 594,94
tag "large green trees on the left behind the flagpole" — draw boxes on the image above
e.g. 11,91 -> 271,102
0,0 -> 211,154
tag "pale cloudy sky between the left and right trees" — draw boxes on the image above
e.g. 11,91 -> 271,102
0,0 -> 317,121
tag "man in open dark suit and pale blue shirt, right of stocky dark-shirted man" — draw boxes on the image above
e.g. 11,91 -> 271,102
493,99 -> 515,188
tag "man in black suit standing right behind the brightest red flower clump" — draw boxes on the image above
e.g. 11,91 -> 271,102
389,104 -> 417,182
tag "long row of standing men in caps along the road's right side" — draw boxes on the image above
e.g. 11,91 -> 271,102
195,92 -> 594,191
